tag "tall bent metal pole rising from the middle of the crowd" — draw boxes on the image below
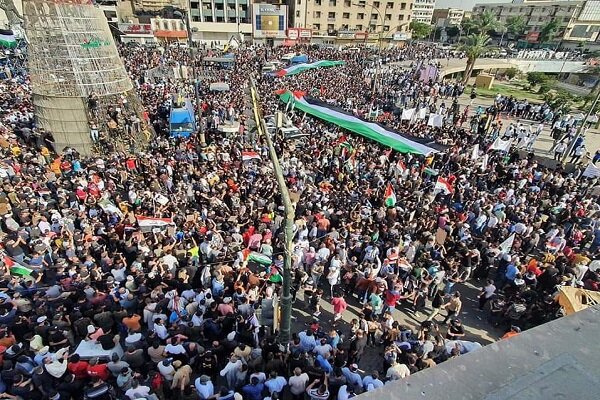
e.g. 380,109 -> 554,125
250,79 -> 296,346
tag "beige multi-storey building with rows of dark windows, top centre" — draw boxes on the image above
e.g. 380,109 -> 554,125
290,0 -> 413,38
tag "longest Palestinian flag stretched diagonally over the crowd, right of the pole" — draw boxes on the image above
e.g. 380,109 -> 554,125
276,90 -> 437,155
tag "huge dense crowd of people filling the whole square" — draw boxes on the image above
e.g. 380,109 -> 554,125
0,40 -> 600,400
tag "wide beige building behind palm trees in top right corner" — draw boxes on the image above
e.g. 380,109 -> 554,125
473,0 -> 600,42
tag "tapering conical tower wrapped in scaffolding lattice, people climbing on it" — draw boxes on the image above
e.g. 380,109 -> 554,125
23,0 -> 149,154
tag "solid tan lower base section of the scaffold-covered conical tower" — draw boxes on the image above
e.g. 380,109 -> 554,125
33,94 -> 92,155
